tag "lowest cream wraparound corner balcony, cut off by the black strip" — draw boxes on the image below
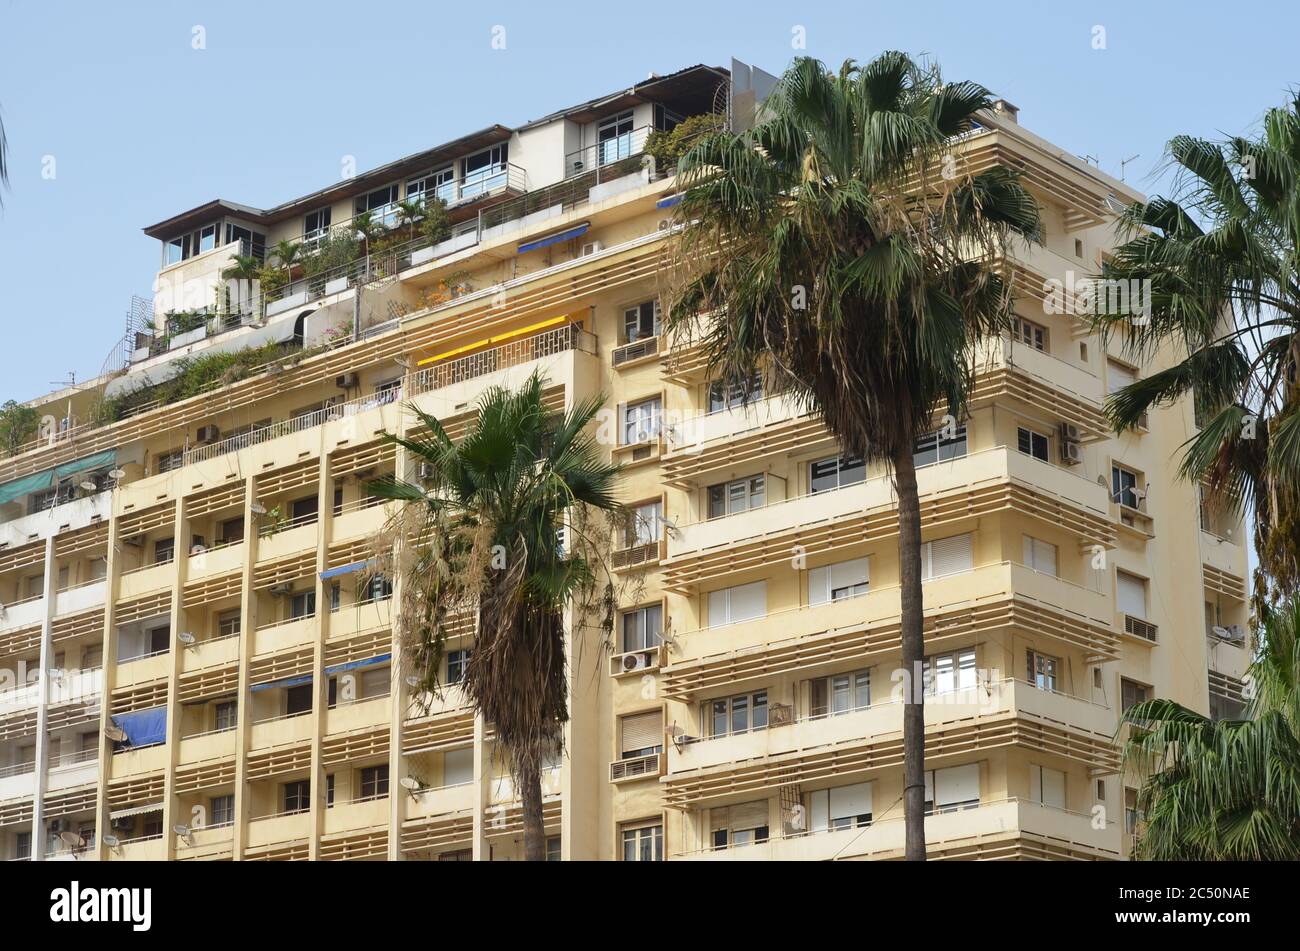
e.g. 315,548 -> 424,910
671,799 -> 1119,861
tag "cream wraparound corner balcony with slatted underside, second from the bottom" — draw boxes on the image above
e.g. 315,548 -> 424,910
664,679 -> 1118,808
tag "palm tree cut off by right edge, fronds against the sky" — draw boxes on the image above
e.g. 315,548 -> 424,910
1093,97 -> 1300,609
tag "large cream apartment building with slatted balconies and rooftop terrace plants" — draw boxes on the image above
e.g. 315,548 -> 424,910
0,64 -> 1249,861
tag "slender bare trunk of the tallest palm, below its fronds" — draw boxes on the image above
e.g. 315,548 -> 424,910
893,440 -> 926,861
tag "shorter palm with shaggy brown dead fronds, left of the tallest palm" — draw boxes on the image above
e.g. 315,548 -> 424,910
369,373 -> 620,860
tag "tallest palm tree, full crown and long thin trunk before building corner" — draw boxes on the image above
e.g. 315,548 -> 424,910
667,52 -> 1037,860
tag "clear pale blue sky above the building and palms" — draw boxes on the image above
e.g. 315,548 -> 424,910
0,0 -> 1300,400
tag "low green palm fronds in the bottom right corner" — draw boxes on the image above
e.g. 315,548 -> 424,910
1121,598 -> 1300,861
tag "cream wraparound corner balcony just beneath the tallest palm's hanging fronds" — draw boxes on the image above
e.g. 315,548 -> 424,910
664,447 -> 1114,592
